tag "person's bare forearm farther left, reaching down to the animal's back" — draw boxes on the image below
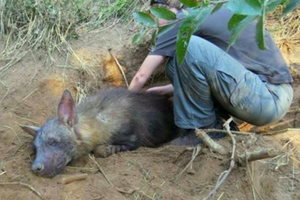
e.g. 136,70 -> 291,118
128,55 -> 165,92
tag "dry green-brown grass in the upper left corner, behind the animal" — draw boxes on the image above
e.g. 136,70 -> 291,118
0,0 -> 141,73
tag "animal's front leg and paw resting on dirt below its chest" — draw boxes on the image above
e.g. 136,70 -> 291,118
93,144 -> 138,158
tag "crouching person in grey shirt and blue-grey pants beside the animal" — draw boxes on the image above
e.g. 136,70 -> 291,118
129,0 -> 293,145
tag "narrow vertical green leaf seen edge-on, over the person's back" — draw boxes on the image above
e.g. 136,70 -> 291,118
256,2 -> 266,49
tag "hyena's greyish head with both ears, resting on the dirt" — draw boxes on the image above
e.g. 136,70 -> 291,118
21,90 -> 77,177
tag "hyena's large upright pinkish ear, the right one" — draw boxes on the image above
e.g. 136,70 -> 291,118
58,90 -> 77,127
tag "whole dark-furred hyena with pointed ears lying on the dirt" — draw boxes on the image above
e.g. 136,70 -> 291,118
22,88 -> 177,176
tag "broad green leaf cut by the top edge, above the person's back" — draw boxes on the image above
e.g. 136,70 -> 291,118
227,0 -> 262,15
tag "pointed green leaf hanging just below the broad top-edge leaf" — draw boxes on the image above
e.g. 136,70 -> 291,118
228,14 -> 256,49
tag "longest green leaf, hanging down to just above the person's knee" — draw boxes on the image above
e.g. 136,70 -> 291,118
176,6 -> 213,64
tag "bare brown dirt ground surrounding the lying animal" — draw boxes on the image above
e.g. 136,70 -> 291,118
0,21 -> 300,200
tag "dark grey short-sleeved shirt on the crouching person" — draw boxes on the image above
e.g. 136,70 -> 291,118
150,8 -> 292,84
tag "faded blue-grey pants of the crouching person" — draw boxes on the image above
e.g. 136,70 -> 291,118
166,36 -> 293,129
